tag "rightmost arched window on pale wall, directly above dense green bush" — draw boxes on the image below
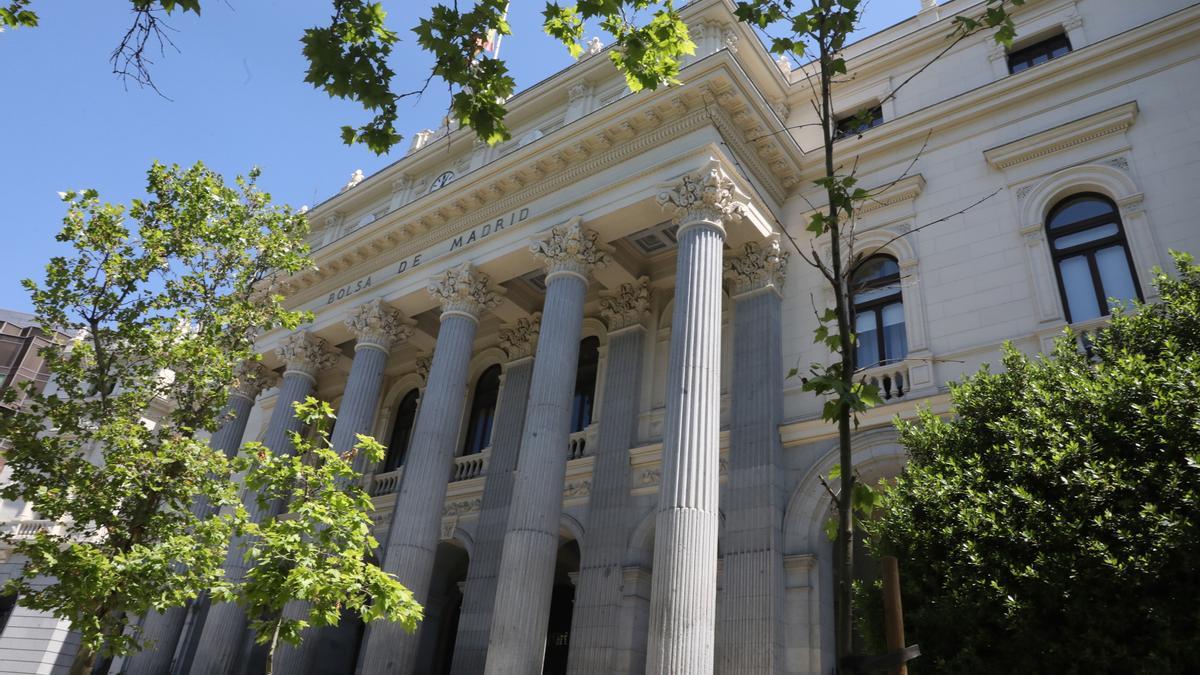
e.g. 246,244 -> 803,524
1046,192 -> 1141,323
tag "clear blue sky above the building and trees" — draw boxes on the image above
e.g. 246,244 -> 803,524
0,0 -> 919,311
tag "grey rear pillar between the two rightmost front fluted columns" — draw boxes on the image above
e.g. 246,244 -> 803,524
568,277 -> 650,675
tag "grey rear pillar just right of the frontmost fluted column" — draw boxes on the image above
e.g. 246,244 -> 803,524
716,241 -> 787,675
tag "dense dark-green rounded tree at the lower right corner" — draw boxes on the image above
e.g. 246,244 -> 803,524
872,255 -> 1200,673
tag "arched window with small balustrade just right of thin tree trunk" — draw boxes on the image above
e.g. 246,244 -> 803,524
850,256 -> 908,368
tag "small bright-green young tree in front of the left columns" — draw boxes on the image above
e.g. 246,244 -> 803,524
215,396 -> 421,675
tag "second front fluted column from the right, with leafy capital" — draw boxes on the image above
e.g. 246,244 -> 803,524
485,219 -> 608,675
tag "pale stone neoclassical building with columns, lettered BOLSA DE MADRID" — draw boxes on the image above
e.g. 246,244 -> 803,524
0,0 -> 1200,675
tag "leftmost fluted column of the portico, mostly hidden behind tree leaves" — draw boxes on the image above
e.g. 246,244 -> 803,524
125,362 -> 277,675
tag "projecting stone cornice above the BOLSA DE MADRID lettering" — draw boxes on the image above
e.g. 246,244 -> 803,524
283,58 -> 800,303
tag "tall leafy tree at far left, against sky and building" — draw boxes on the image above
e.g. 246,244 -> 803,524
0,163 -> 308,674
